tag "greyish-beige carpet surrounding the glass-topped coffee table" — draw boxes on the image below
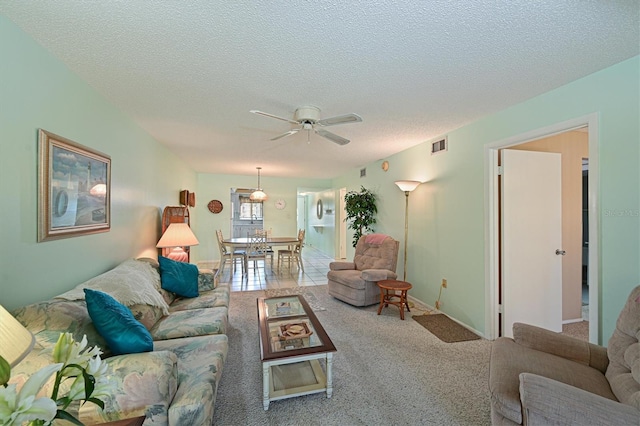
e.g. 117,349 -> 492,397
214,285 -> 491,426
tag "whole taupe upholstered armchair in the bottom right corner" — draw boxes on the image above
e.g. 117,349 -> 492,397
489,286 -> 640,425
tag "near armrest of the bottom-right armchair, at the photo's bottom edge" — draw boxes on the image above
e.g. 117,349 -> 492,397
520,373 -> 640,425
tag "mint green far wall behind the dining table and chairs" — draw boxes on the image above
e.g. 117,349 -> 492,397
192,169 -> 331,263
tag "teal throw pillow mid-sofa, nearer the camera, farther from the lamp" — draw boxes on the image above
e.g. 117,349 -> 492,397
84,288 -> 153,355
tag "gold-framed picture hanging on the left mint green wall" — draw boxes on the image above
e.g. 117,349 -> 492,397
38,129 -> 111,242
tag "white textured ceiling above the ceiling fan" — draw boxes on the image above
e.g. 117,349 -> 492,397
0,0 -> 640,178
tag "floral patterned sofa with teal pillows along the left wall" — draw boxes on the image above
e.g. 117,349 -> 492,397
11,259 -> 229,425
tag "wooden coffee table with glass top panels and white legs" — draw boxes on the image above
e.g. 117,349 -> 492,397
258,295 -> 336,410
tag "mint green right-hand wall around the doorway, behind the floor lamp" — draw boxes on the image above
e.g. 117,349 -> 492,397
333,57 -> 640,343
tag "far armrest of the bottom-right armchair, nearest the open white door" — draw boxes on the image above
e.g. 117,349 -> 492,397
513,323 -> 609,373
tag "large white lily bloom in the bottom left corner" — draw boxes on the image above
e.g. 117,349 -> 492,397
0,363 -> 62,426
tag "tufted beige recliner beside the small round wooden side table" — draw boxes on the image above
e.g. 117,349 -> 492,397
327,234 -> 399,306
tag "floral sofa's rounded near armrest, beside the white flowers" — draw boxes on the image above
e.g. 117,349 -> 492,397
78,351 -> 178,424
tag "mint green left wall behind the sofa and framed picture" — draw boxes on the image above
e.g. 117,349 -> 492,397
0,16 -> 196,309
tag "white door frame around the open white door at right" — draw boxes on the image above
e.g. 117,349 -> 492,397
485,114 -> 599,342
